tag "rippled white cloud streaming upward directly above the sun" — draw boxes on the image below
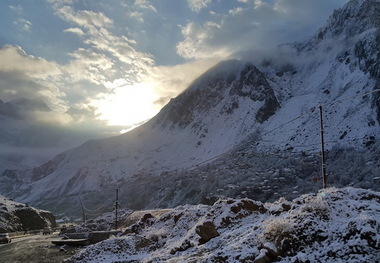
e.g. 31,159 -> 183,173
56,1 -> 154,85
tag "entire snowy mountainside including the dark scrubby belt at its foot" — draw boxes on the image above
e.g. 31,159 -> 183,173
0,0 -> 380,219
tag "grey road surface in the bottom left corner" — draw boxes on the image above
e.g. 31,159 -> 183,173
0,234 -> 80,263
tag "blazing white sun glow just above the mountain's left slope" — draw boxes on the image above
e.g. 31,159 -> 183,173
92,83 -> 160,128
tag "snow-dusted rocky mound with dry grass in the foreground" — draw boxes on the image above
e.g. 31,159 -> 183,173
70,188 -> 380,263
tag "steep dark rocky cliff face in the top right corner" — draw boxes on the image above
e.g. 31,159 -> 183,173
314,0 -> 380,122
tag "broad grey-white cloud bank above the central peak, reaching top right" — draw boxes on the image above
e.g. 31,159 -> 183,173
176,0 -> 347,59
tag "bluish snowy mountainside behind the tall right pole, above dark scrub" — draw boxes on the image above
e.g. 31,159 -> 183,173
263,0 -> 380,149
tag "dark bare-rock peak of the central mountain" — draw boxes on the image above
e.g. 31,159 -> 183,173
156,60 -> 280,128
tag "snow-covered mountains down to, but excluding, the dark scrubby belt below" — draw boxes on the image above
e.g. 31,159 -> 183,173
0,0 -> 380,219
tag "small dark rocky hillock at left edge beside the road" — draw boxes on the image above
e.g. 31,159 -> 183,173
0,196 -> 57,233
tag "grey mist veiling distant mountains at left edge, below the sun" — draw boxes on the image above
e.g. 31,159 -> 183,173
0,98 -> 119,172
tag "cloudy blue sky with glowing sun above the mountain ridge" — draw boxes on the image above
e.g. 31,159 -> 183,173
0,0 -> 348,167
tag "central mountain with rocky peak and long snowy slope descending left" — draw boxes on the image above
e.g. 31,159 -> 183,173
2,61 -> 279,208
